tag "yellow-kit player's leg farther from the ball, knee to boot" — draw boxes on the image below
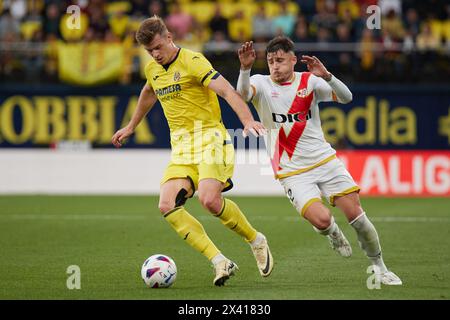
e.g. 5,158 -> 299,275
199,179 -> 273,277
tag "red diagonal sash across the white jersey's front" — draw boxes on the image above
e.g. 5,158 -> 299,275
272,72 -> 314,173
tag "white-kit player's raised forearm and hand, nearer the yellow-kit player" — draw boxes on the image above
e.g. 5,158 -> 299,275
236,41 -> 256,101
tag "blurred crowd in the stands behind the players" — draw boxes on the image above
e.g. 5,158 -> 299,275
0,0 -> 450,84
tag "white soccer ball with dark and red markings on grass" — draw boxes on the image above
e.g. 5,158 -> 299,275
141,254 -> 177,288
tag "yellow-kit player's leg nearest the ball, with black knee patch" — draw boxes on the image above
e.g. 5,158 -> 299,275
159,179 -> 235,286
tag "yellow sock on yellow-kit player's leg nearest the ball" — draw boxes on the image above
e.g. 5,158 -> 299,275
164,207 -> 220,260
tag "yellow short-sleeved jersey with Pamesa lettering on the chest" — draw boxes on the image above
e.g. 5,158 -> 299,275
145,48 -> 227,134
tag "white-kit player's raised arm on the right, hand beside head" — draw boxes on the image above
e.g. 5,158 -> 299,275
301,55 -> 353,103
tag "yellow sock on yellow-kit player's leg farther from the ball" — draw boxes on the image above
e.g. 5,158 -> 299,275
217,199 -> 257,242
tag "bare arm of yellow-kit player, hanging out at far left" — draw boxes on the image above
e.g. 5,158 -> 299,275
111,84 -> 157,148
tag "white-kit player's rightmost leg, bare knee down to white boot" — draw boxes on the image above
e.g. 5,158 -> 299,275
334,192 -> 402,285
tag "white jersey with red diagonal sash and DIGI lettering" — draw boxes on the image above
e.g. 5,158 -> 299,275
250,72 -> 336,178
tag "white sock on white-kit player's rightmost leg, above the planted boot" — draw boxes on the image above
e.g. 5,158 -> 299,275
350,212 -> 387,273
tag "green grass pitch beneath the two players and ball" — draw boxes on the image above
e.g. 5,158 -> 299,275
0,196 -> 450,300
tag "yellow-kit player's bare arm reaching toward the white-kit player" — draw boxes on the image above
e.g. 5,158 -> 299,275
208,76 -> 266,136
